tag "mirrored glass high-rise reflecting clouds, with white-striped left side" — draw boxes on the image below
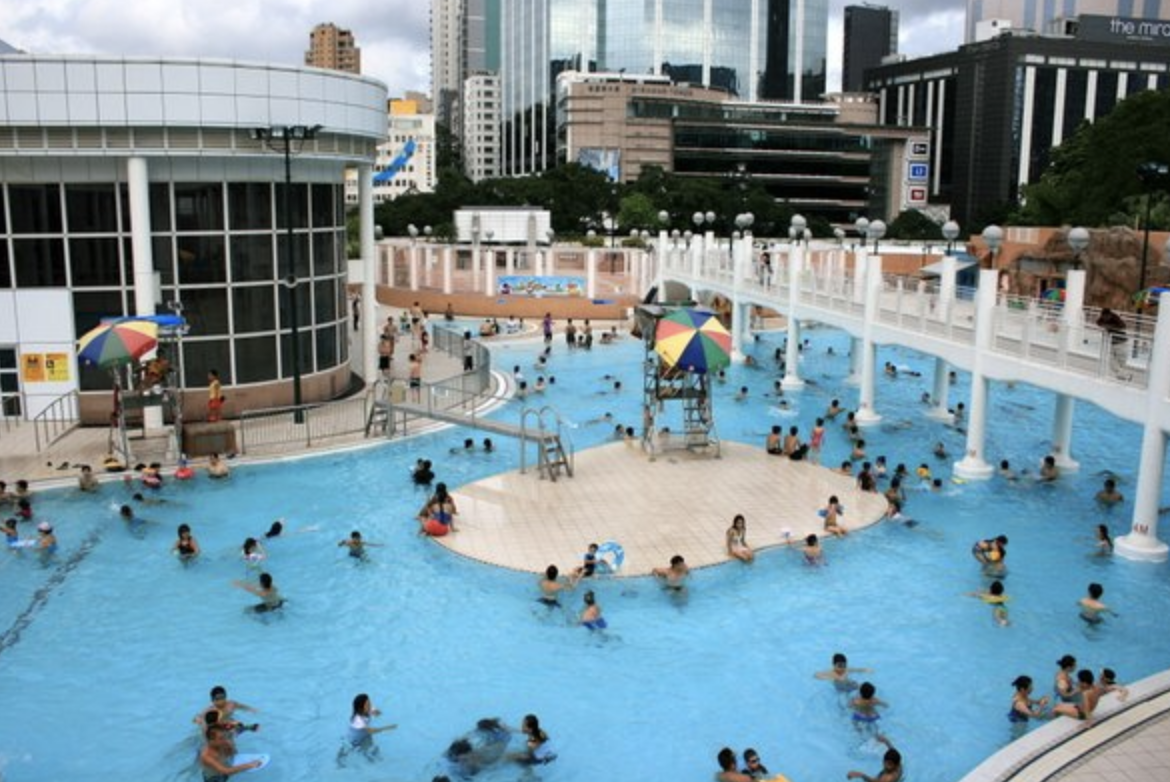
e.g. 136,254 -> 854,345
501,0 -> 828,176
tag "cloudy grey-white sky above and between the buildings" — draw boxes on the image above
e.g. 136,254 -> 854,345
0,0 -> 965,95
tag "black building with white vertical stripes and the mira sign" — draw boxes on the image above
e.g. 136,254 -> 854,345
867,27 -> 1170,224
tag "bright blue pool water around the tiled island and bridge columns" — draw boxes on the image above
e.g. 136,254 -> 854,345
0,331 -> 1170,782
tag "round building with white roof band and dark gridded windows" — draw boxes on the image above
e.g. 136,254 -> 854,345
0,55 -> 386,421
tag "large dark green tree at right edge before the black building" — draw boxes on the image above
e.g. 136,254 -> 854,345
1019,90 -> 1170,228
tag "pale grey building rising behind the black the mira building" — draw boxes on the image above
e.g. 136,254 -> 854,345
966,0 -> 1170,43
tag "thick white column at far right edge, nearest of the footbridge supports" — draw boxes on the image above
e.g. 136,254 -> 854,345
1114,299 -> 1170,562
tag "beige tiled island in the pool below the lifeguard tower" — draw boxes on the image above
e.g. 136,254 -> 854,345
435,441 -> 886,576
